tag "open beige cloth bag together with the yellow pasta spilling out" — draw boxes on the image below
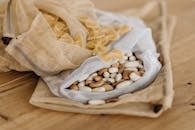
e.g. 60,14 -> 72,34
0,0 -> 129,73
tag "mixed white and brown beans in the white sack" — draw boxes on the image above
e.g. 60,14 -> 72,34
69,51 -> 145,104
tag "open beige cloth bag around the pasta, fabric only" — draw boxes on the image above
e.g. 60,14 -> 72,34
0,0 -> 96,76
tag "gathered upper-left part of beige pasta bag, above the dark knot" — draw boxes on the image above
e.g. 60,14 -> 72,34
3,0 -> 38,38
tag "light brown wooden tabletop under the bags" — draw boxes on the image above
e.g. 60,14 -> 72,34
0,0 -> 195,130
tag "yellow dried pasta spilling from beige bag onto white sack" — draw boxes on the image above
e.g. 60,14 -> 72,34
42,12 -> 130,60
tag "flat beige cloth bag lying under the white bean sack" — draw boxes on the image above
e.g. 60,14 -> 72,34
30,1 -> 175,118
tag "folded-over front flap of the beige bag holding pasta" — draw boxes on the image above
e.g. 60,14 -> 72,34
6,13 -> 90,76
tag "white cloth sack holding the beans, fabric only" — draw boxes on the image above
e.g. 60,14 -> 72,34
42,10 -> 161,103
